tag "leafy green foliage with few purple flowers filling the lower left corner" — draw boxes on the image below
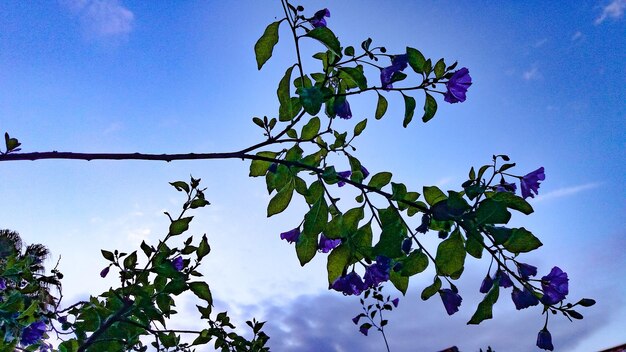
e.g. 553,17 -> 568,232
0,177 -> 269,352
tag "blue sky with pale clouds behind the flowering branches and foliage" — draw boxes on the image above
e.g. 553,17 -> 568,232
0,0 -> 626,351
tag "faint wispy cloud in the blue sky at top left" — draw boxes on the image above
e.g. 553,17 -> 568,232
60,0 -> 135,38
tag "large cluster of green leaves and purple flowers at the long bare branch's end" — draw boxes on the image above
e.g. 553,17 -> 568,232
250,1 -> 593,349
